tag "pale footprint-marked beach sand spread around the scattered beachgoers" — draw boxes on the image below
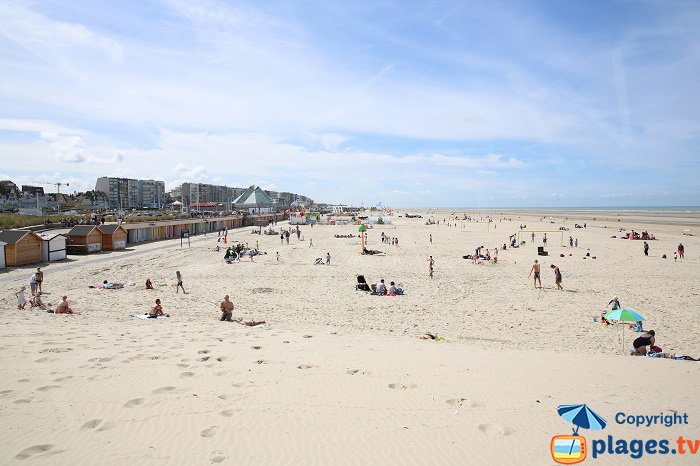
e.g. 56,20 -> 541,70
0,211 -> 700,464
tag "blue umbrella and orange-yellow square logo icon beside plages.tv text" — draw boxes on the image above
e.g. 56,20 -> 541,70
549,404 -> 608,464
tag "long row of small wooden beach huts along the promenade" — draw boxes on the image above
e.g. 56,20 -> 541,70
0,214 -> 284,269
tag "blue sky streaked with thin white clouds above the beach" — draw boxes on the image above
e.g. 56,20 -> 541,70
0,0 -> 700,207
